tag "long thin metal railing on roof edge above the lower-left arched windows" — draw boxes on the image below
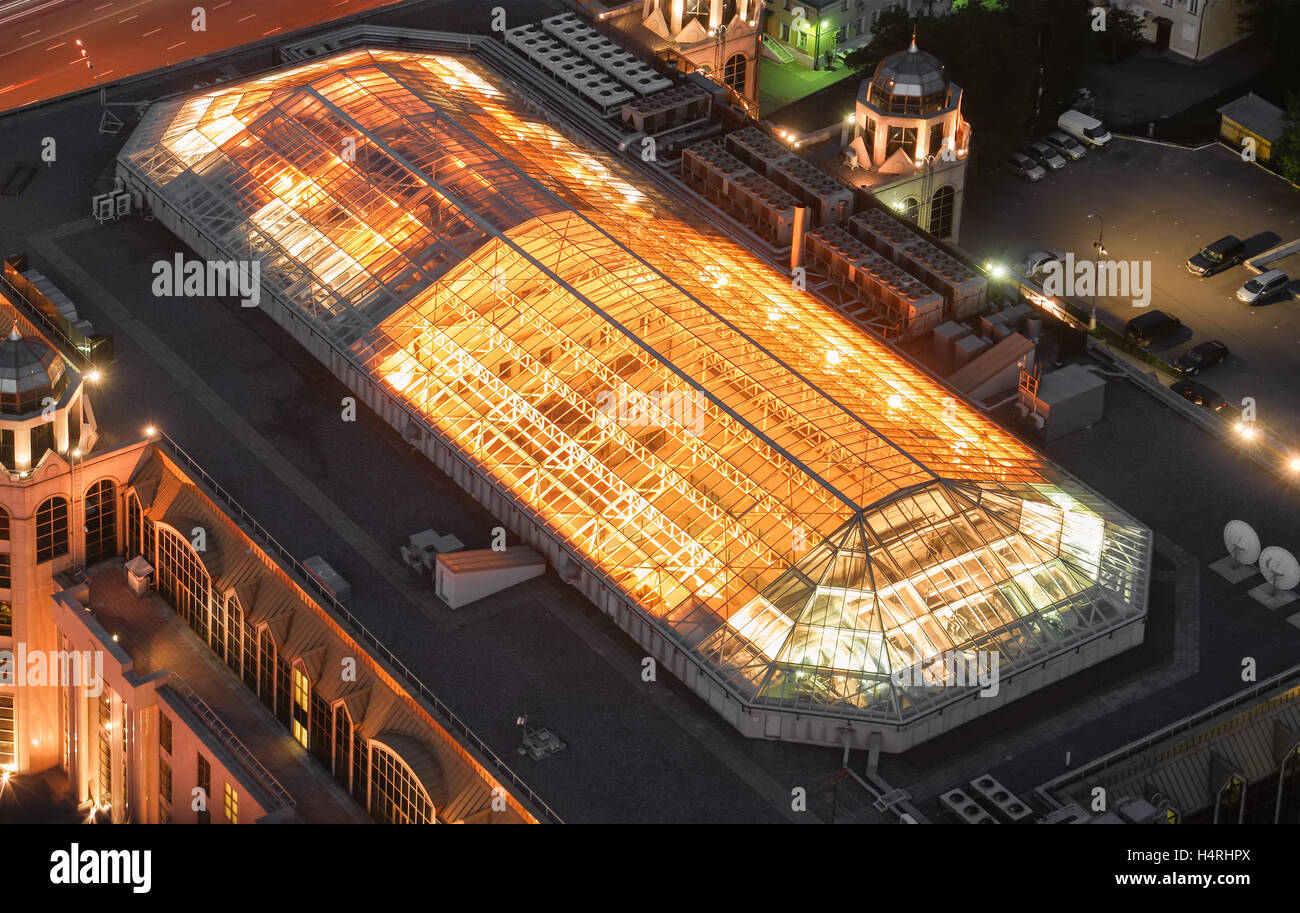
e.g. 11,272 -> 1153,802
156,432 -> 564,825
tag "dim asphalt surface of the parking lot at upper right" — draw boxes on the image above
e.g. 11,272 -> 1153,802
962,138 -> 1300,440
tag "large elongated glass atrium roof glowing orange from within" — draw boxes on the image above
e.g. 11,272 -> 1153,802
120,49 -> 1151,721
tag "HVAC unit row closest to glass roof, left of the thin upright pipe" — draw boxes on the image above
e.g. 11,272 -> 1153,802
681,139 -> 803,248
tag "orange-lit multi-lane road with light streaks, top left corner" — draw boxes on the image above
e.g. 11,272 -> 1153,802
0,0 -> 553,112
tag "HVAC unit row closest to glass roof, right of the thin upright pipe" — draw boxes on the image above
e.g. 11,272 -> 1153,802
803,225 -> 944,338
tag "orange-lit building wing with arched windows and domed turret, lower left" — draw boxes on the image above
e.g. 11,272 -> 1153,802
0,286 -> 536,823
